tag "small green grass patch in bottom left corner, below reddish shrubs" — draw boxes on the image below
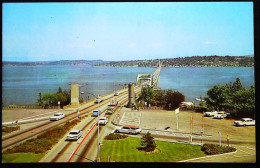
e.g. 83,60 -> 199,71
2,153 -> 45,163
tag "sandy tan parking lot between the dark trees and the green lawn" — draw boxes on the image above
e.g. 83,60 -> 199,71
119,108 -> 255,144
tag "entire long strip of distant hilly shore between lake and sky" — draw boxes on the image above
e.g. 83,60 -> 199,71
2,55 -> 254,68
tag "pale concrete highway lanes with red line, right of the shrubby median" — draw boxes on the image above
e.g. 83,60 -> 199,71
40,88 -> 140,162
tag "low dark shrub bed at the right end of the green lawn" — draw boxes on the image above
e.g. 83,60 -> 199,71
201,143 -> 236,155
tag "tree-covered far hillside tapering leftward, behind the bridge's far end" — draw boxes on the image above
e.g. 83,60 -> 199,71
96,55 -> 254,67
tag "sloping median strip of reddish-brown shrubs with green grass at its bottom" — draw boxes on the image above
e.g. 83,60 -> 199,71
2,119 -> 79,163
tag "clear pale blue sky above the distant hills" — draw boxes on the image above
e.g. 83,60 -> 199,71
2,2 -> 254,61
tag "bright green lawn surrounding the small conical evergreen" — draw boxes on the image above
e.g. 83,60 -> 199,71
101,137 -> 206,162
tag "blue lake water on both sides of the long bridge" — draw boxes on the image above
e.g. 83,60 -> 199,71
2,66 -> 254,105
